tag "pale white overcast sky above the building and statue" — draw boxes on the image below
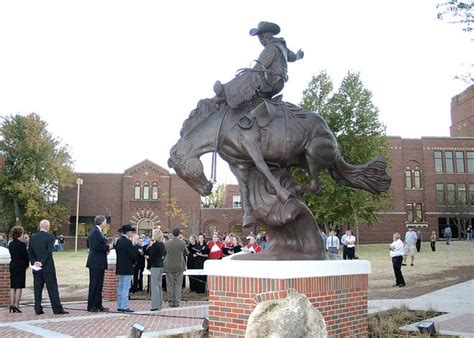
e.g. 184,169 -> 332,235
0,0 -> 474,183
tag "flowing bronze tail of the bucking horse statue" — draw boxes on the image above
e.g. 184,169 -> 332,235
328,155 -> 392,194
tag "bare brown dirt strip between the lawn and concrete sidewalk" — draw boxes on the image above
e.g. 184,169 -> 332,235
369,265 -> 474,299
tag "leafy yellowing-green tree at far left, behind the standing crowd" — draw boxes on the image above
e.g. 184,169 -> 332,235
0,113 -> 74,231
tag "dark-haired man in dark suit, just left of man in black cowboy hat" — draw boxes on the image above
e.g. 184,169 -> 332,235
86,215 -> 111,312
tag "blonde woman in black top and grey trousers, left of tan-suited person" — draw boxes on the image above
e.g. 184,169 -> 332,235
148,229 -> 165,311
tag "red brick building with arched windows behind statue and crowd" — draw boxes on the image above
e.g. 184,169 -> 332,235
61,86 -> 474,243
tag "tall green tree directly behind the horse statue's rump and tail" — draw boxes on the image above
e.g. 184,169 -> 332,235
293,71 -> 389,228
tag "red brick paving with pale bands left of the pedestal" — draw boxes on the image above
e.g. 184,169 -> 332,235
0,300 -> 208,337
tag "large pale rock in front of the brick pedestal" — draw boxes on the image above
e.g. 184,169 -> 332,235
245,293 -> 328,338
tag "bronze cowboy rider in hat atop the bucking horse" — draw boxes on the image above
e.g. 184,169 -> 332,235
214,21 -> 304,108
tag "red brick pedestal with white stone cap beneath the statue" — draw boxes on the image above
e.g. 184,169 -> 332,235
204,260 -> 370,337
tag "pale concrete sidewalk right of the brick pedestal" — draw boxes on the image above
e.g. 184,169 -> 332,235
369,280 -> 474,337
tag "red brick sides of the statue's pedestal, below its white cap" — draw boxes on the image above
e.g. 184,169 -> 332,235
208,274 -> 368,337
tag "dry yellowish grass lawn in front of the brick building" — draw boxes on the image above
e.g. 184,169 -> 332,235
23,241 -> 474,301
